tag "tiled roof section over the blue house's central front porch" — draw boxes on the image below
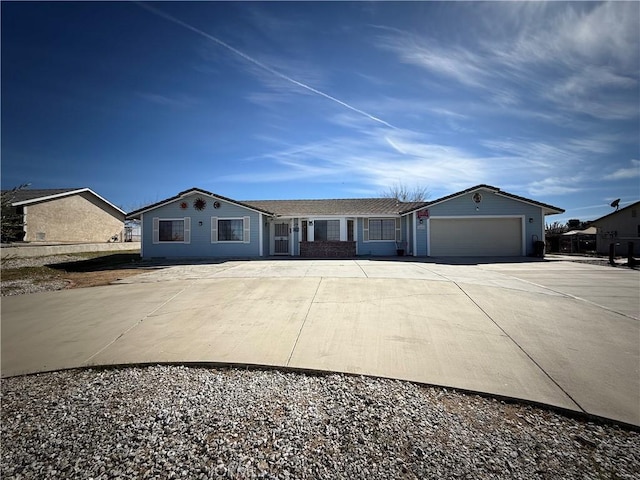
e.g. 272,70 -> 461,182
244,198 -> 424,217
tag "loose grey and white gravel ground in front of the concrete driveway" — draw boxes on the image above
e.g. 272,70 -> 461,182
0,366 -> 640,479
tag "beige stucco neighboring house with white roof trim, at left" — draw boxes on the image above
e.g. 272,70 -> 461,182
12,188 -> 125,243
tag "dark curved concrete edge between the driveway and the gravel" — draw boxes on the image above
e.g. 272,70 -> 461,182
2,361 -> 640,432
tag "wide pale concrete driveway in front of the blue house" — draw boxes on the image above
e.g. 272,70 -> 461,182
2,259 -> 640,425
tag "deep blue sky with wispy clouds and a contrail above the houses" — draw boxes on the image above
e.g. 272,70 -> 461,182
1,2 -> 640,222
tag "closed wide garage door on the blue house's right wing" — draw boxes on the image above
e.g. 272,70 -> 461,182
429,218 -> 522,257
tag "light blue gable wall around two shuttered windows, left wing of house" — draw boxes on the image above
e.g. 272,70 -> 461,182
142,194 -> 268,258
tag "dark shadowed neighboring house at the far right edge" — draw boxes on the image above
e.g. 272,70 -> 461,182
591,202 -> 640,256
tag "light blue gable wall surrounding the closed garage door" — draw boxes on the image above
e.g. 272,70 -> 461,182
417,190 -> 544,256
